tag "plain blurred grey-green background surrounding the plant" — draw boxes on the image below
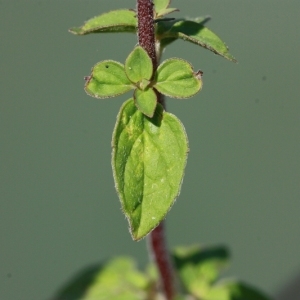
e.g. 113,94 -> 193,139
0,0 -> 300,300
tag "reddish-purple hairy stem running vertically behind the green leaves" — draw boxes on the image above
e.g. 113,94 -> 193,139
137,0 -> 175,300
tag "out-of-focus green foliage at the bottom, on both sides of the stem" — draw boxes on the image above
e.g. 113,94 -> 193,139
53,246 -> 270,300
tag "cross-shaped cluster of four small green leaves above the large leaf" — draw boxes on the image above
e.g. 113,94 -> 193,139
85,46 -> 202,118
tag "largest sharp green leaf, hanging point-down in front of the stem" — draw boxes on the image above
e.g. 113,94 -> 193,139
112,99 -> 188,240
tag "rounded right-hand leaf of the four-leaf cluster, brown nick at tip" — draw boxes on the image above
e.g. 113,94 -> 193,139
154,58 -> 202,98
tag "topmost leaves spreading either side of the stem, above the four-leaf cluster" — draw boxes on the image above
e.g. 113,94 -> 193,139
69,7 -> 236,62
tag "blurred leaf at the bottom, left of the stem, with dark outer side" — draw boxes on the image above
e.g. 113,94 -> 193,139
53,257 -> 150,300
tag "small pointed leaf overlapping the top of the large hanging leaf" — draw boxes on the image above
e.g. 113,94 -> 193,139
134,89 -> 157,118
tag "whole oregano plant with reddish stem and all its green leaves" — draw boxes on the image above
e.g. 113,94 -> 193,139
54,0 -> 269,300
